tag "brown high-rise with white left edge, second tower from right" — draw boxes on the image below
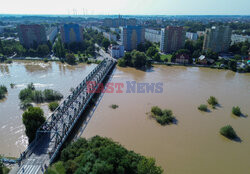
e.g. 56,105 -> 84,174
160,26 -> 185,53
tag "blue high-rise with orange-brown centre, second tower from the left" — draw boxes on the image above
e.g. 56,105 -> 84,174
61,24 -> 83,43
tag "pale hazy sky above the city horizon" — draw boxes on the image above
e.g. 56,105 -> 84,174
0,0 -> 250,15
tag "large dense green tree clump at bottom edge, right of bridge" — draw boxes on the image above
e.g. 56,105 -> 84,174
53,136 -> 163,174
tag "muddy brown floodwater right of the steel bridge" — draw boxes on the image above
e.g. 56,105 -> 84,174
82,66 -> 250,174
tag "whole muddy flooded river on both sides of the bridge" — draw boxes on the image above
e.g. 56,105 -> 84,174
0,61 -> 250,174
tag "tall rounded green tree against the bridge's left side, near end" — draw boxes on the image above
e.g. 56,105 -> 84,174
22,107 -> 46,143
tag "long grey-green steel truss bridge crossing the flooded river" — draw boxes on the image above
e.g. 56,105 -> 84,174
11,59 -> 116,174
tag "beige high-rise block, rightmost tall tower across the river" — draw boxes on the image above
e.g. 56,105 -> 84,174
203,26 -> 232,53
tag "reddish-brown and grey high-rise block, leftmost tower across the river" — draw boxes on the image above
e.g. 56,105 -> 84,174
17,24 -> 47,48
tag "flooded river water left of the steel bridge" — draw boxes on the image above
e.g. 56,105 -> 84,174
0,61 -> 96,157
